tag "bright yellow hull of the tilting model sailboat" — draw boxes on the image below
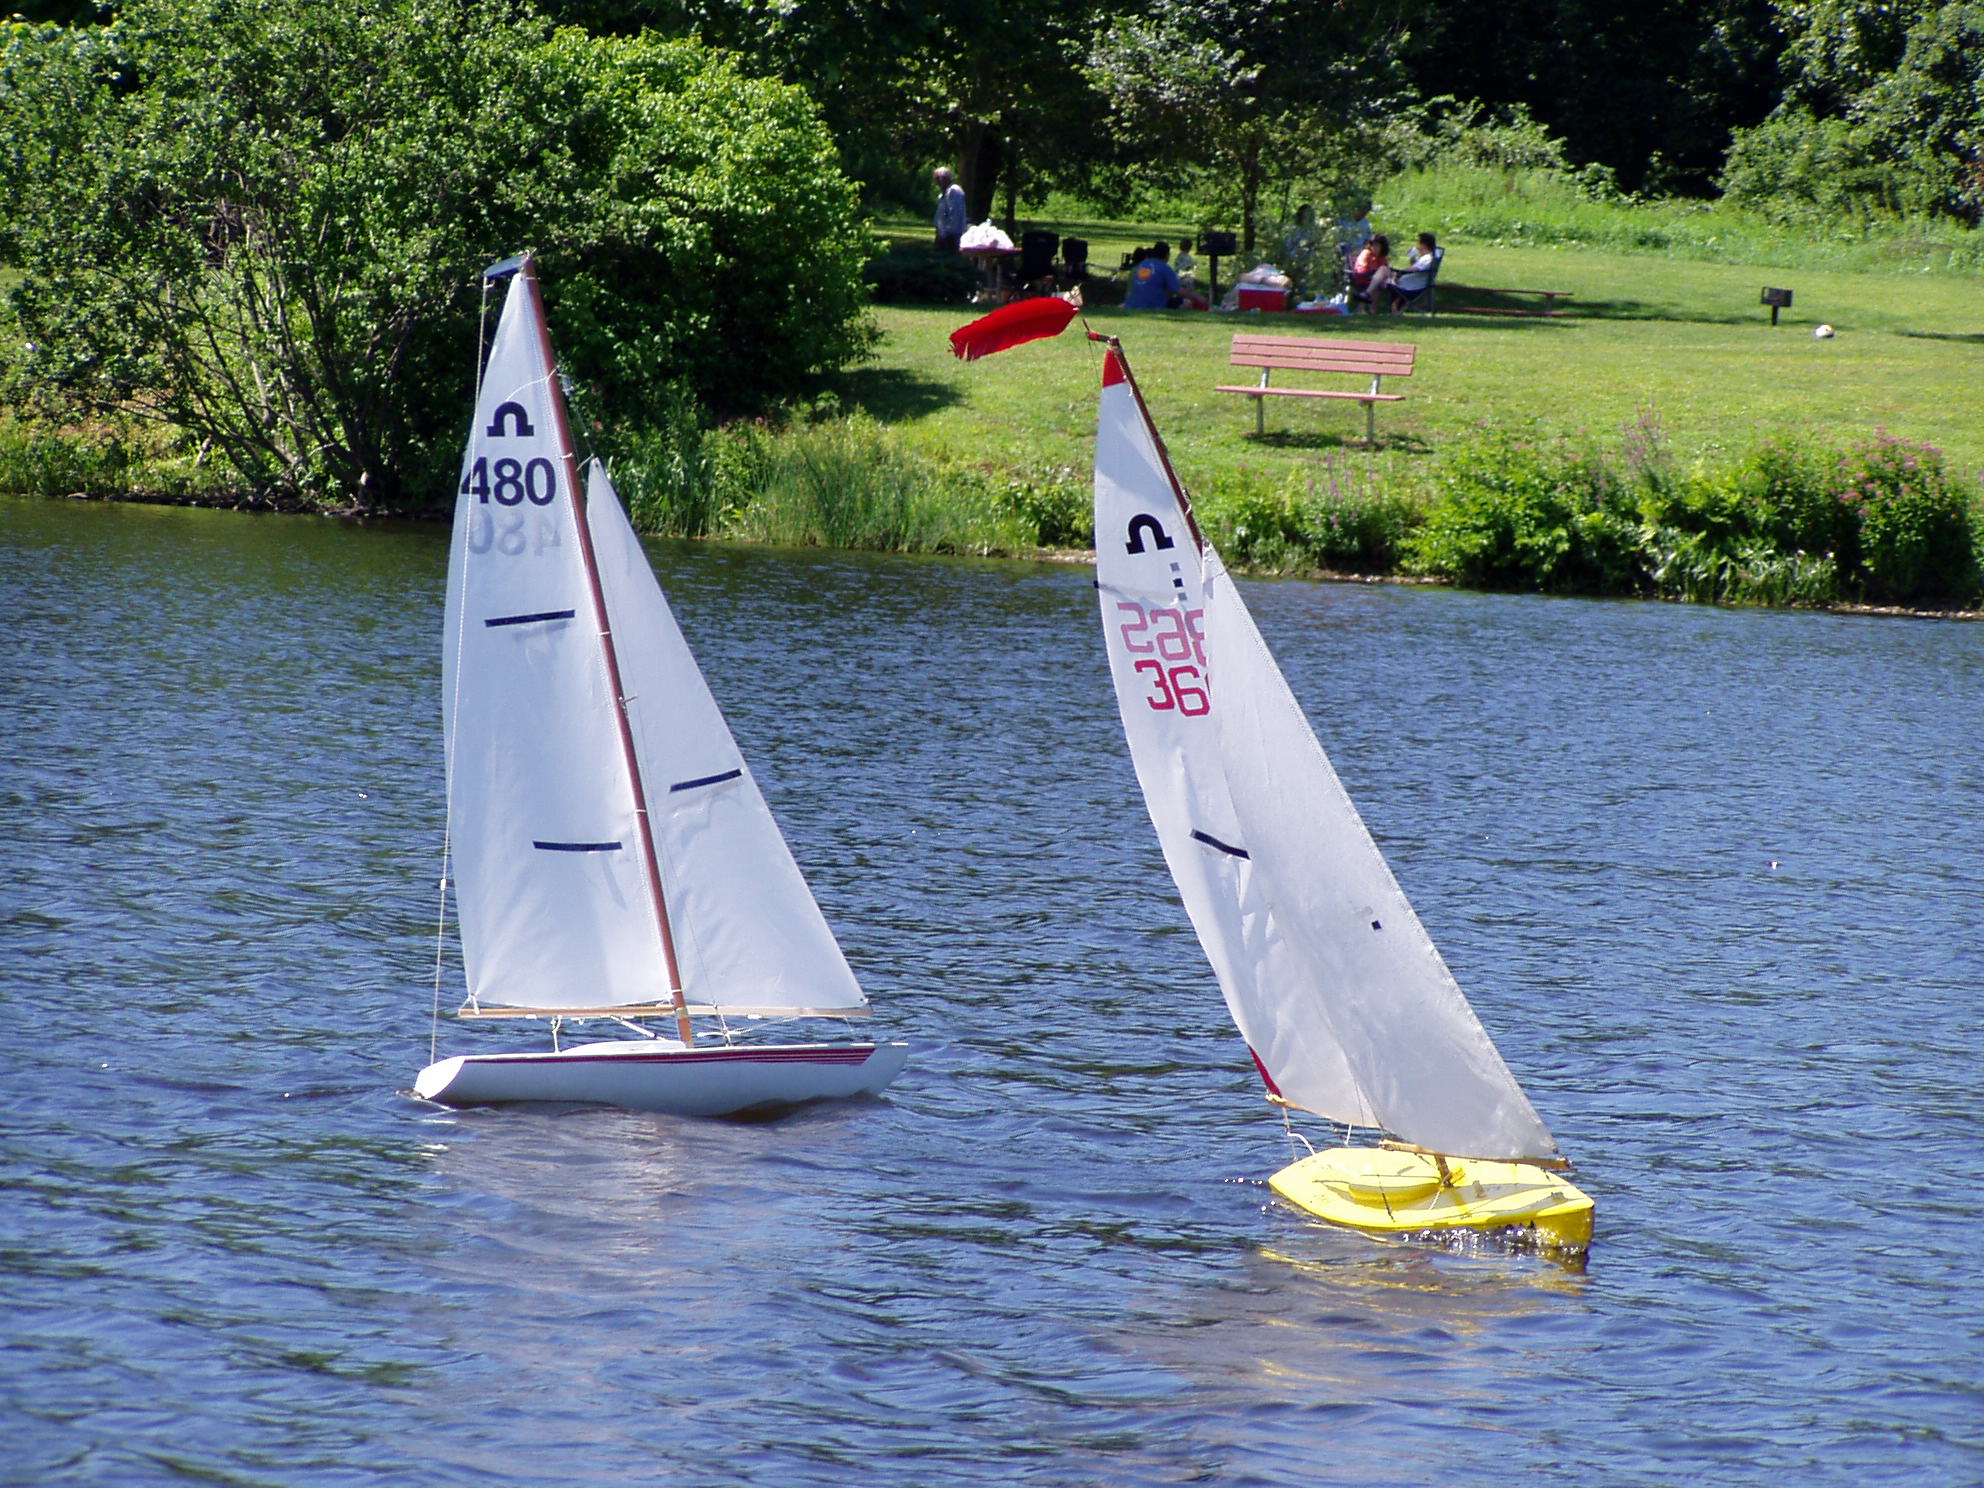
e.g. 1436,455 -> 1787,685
1268,1147 -> 1591,1252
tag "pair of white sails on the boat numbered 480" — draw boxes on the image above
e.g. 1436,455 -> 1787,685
442,274 -> 865,1014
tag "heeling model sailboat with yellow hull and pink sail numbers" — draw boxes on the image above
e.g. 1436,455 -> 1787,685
1095,337 -> 1591,1252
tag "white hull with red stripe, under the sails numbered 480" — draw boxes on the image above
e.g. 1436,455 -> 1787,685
413,1040 -> 909,1117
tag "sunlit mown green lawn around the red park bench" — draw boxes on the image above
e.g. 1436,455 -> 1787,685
841,236 -> 1984,503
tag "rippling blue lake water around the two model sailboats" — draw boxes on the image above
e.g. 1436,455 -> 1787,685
11,502 -> 1984,1488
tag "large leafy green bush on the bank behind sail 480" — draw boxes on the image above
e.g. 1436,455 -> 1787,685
0,0 -> 871,504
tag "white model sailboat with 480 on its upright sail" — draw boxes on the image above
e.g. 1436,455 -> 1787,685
415,256 -> 907,1115
